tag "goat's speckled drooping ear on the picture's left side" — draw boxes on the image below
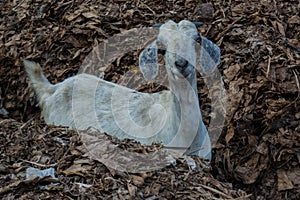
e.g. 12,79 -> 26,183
139,40 -> 158,80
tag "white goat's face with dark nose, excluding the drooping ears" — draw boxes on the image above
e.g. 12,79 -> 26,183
156,20 -> 200,82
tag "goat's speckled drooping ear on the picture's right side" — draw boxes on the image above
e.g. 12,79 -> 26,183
200,36 -> 220,74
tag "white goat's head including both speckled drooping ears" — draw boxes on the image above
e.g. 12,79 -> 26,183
139,20 -> 220,84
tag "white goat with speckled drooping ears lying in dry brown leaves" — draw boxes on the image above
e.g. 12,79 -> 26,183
23,20 -> 220,160
